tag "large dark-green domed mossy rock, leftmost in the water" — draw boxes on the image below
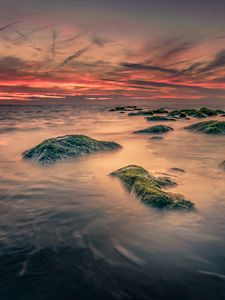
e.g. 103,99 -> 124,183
22,135 -> 121,164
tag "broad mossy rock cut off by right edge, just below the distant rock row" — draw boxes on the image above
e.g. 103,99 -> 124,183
185,120 -> 225,135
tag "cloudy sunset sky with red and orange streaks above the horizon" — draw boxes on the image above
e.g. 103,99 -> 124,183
0,0 -> 225,102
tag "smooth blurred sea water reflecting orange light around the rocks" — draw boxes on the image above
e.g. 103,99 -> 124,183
0,103 -> 225,300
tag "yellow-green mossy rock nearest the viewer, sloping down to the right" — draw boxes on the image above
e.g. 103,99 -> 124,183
111,165 -> 194,209
